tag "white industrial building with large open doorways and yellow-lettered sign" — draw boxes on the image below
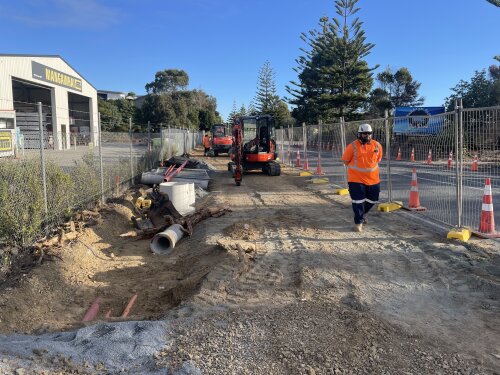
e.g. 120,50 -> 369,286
0,54 -> 98,151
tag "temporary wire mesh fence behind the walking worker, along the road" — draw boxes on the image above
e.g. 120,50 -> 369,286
282,107 -> 500,236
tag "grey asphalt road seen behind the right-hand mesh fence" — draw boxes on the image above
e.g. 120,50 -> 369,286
283,149 -> 500,232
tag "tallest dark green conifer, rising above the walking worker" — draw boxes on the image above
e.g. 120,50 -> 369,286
287,0 -> 378,122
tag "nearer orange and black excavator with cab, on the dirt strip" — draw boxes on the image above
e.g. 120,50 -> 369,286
228,115 -> 281,186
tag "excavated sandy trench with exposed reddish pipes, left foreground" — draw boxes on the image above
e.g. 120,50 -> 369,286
0,188 -> 225,334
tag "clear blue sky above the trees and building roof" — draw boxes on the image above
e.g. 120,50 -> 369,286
0,0 -> 500,119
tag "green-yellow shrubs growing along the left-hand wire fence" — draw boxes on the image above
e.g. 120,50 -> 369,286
0,152 -> 153,250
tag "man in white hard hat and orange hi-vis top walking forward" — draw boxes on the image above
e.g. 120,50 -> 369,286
342,124 -> 382,232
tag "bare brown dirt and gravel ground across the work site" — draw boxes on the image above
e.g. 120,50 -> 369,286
0,148 -> 500,374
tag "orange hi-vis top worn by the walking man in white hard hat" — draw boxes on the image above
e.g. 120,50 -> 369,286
342,139 -> 382,185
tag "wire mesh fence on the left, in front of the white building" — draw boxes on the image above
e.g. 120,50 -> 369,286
0,95 -> 201,260
